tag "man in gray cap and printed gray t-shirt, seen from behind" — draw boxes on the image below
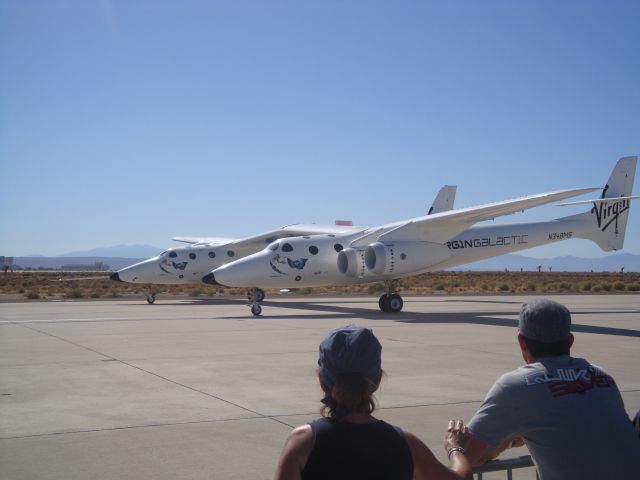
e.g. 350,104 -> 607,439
467,300 -> 640,480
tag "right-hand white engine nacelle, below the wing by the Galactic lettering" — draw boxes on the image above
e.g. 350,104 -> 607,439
364,241 -> 451,275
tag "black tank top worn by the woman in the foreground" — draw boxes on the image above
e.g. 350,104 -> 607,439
302,418 -> 413,480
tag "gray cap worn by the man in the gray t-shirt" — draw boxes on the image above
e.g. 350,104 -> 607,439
518,299 -> 571,343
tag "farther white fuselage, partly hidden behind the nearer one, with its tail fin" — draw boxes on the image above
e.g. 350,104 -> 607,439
110,185 -> 456,304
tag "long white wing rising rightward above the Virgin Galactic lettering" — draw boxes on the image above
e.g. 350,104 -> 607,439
364,188 -> 600,246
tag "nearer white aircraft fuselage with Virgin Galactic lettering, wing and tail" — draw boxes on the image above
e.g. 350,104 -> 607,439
203,157 -> 640,315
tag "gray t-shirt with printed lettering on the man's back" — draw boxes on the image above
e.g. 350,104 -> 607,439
469,355 -> 640,480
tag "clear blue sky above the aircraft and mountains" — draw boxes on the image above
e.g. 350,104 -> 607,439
0,0 -> 640,256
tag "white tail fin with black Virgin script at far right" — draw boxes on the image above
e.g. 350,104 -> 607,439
563,157 -> 640,252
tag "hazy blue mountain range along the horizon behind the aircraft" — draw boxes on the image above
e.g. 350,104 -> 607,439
6,245 -> 640,272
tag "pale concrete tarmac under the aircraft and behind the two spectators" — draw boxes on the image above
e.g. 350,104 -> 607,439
0,295 -> 640,480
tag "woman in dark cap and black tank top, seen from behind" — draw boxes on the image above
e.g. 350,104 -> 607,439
275,325 -> 471,480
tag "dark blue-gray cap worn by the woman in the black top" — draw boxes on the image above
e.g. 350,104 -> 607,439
318,325 -> 382,388
